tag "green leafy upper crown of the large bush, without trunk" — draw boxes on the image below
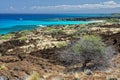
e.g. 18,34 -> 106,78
73,35 -> 104,54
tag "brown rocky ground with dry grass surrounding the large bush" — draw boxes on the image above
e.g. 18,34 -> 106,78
0,17 -> 120,80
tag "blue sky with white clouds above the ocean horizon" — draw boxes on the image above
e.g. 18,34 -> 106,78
0,0 -> 120,13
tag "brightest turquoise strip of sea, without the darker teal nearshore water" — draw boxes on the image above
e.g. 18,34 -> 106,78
0,20 -> 90,29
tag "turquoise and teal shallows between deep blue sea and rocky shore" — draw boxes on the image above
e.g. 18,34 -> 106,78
0,20 -> 90,34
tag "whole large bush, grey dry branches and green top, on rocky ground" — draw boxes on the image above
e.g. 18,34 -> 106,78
58,36 -> 115,71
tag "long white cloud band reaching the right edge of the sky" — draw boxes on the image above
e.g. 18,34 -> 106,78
30,1 -> 120,10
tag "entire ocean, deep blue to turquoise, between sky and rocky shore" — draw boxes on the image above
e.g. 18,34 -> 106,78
0,14 -> 110,34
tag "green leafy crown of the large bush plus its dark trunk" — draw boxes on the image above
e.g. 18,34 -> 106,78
72,35 -> 105,68
